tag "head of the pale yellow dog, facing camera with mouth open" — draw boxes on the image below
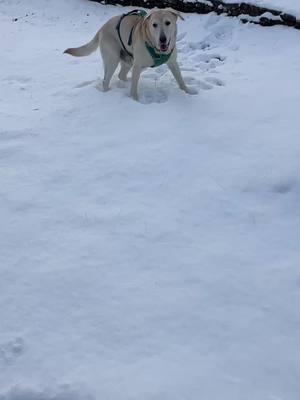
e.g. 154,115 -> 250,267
144,8 -> 184,53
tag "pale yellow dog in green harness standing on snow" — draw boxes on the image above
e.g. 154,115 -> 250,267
65,8 -> 197,100
